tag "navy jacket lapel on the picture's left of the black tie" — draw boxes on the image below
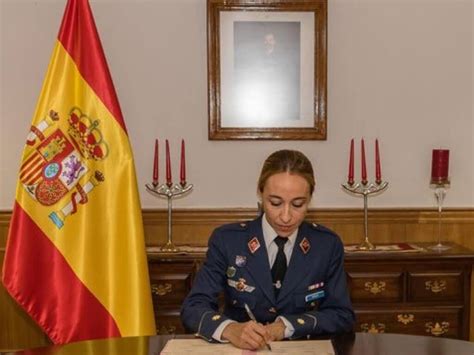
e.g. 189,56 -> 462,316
246,217 -> 275,304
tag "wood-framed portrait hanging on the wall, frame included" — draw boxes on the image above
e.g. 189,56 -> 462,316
207,0 -> 327,140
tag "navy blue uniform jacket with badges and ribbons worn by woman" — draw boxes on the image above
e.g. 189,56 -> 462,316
181,217 -> 355,341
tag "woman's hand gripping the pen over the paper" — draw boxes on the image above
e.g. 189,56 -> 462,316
221,321 -> 271,350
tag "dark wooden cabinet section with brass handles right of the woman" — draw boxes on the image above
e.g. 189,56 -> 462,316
345,245 -> 474,340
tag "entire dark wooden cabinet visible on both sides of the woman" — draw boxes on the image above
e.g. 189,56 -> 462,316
148,245 -> 474,340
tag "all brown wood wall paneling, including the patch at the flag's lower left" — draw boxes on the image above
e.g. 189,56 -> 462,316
0,209 -> 474,349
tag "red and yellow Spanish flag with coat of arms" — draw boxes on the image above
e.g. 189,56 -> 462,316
2,0 -> 155,344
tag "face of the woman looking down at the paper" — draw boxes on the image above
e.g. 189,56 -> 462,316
262,172 -> 311,237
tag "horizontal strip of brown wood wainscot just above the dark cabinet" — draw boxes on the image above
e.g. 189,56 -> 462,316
0,208 -> 474,251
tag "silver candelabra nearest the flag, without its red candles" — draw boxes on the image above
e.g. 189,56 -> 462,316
145,182 -> 193,253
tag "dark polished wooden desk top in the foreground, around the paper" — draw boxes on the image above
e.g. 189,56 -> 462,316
0,333 -> 474,355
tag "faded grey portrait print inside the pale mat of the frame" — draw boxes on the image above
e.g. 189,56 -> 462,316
232,21 -> 301,127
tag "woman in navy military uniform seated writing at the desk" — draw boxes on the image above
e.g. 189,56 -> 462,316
181,150 -> 355,349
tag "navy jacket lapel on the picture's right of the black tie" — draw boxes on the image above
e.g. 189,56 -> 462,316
278,223 -> 314,300
